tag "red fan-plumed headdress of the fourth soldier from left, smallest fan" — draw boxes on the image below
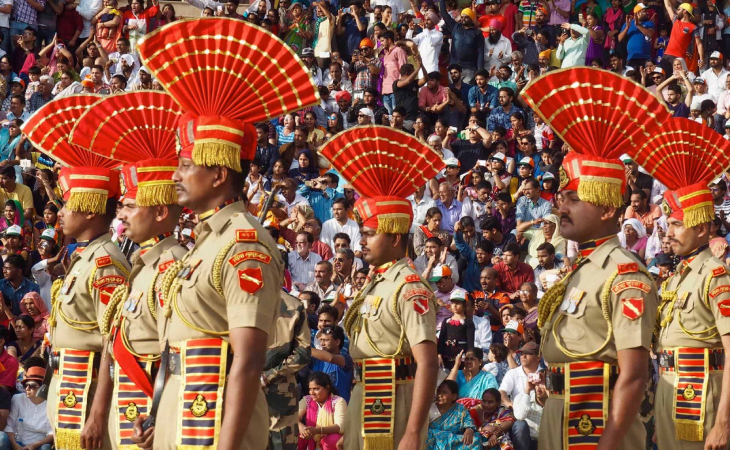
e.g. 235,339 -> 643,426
321,125 -> 444,234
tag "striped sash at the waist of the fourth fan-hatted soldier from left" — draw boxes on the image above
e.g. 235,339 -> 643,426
362,358 -> 396,450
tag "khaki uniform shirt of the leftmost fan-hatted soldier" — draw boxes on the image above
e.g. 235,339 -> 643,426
51,234 -> 129,352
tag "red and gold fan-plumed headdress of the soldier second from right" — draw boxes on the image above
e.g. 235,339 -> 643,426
522,67 -> 670,207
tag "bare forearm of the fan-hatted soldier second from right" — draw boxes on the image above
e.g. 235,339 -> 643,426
596,347 -> 649,450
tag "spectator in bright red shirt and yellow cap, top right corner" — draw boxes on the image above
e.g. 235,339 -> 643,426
661,0 -> 705,72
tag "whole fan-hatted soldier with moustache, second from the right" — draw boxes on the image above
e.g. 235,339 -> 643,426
524,69 -> 666,450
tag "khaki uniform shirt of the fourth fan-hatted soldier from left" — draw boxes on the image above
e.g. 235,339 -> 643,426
350,258 -> 437,359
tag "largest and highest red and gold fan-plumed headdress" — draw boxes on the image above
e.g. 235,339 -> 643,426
138,17 -> 320,171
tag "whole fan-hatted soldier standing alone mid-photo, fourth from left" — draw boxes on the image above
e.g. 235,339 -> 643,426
322,126 -> 443,450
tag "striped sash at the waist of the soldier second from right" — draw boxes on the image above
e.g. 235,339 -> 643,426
563,361 -> 611,450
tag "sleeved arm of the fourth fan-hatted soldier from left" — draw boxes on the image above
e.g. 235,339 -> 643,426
398,283 -> 438,450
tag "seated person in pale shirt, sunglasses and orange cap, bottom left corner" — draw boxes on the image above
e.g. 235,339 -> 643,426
3,357 -> 53,450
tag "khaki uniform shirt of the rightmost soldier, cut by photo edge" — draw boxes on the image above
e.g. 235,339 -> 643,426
656,248 -> 730,351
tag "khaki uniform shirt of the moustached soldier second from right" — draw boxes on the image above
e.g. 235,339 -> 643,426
541,238 -> 657,364
